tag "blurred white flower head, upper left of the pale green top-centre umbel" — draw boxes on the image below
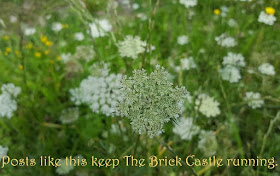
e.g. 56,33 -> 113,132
89,19 -> 112,38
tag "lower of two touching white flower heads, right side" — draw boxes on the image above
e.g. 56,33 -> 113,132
219,65 -> 241,83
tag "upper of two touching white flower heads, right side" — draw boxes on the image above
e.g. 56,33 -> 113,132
223,52 -> 246,67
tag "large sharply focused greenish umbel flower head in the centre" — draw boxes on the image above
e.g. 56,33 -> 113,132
117,65 -> 187,137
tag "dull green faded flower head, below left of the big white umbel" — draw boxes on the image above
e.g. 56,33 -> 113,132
59,108 -> 79,124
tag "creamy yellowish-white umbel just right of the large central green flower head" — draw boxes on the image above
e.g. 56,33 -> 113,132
195,94 -> 221,117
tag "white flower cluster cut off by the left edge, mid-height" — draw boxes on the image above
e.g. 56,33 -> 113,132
0,83 -> 21,118
